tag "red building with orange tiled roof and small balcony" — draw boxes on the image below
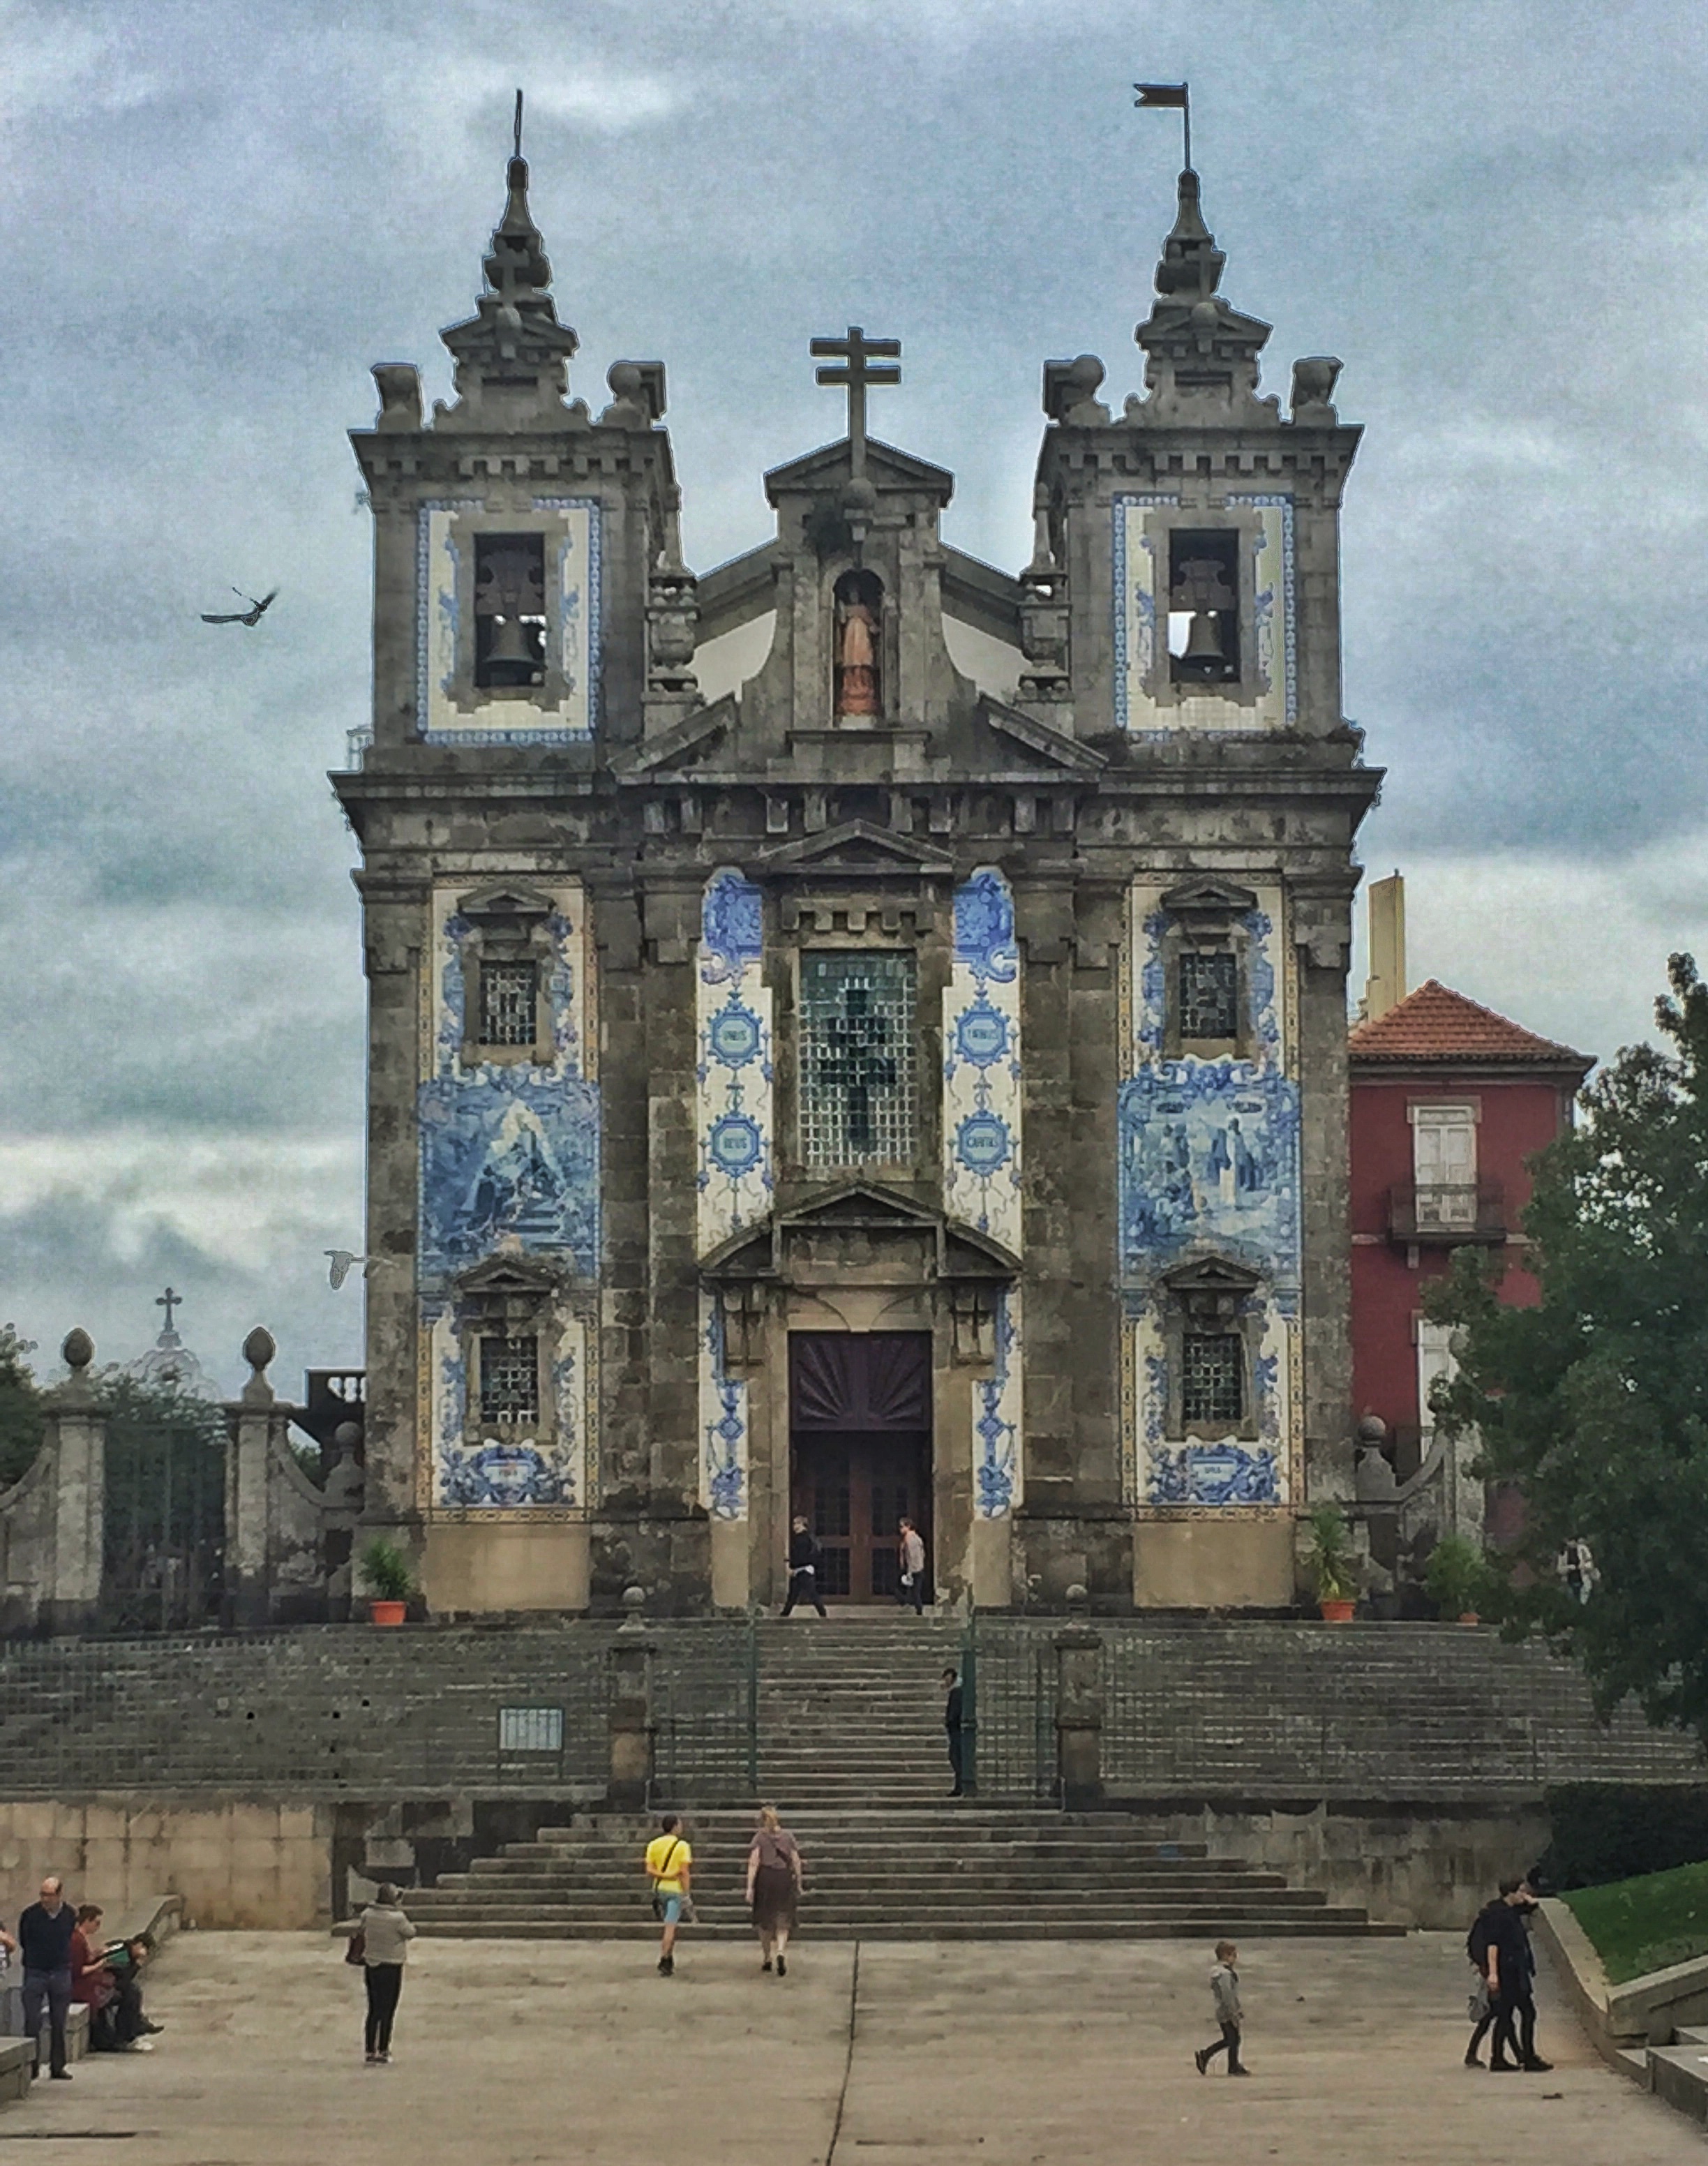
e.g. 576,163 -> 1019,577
1349,974 -> 1594,1481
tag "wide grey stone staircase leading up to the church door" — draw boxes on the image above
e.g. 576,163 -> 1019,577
409,1611 -> 1400,1941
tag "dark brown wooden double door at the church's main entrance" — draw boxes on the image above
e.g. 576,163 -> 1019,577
788,1332 -> 931,1603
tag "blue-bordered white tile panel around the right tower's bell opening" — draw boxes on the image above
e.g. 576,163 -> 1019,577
1111,494 -> 1299,736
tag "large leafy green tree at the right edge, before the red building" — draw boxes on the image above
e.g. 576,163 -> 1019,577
1429,955 -> 1708,1740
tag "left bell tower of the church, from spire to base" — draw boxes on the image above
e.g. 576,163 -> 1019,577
336,123 -> 695,1613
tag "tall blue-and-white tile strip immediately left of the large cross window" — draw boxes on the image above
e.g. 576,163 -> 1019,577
695,871 -> 775,1256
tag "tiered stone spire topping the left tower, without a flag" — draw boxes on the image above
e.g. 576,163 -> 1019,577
435,124 -> 587,429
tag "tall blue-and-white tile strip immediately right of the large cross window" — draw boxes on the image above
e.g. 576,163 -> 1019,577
944,867 -> 1021,1256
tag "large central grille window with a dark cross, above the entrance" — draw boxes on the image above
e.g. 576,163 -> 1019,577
801,949 -> 918,1165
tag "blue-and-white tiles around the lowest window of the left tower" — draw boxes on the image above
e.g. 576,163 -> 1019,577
422,1304 -> 591,1512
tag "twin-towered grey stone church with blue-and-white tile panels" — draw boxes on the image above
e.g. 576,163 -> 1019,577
336,144 -> 1379,1613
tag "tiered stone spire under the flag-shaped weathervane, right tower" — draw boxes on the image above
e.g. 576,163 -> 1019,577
1128,167 -> 1280,424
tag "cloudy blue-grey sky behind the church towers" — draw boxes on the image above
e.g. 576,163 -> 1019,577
0,0 -> 1708,1391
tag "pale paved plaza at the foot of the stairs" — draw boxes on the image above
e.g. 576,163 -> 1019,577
0,1932 -> 1702,2166
